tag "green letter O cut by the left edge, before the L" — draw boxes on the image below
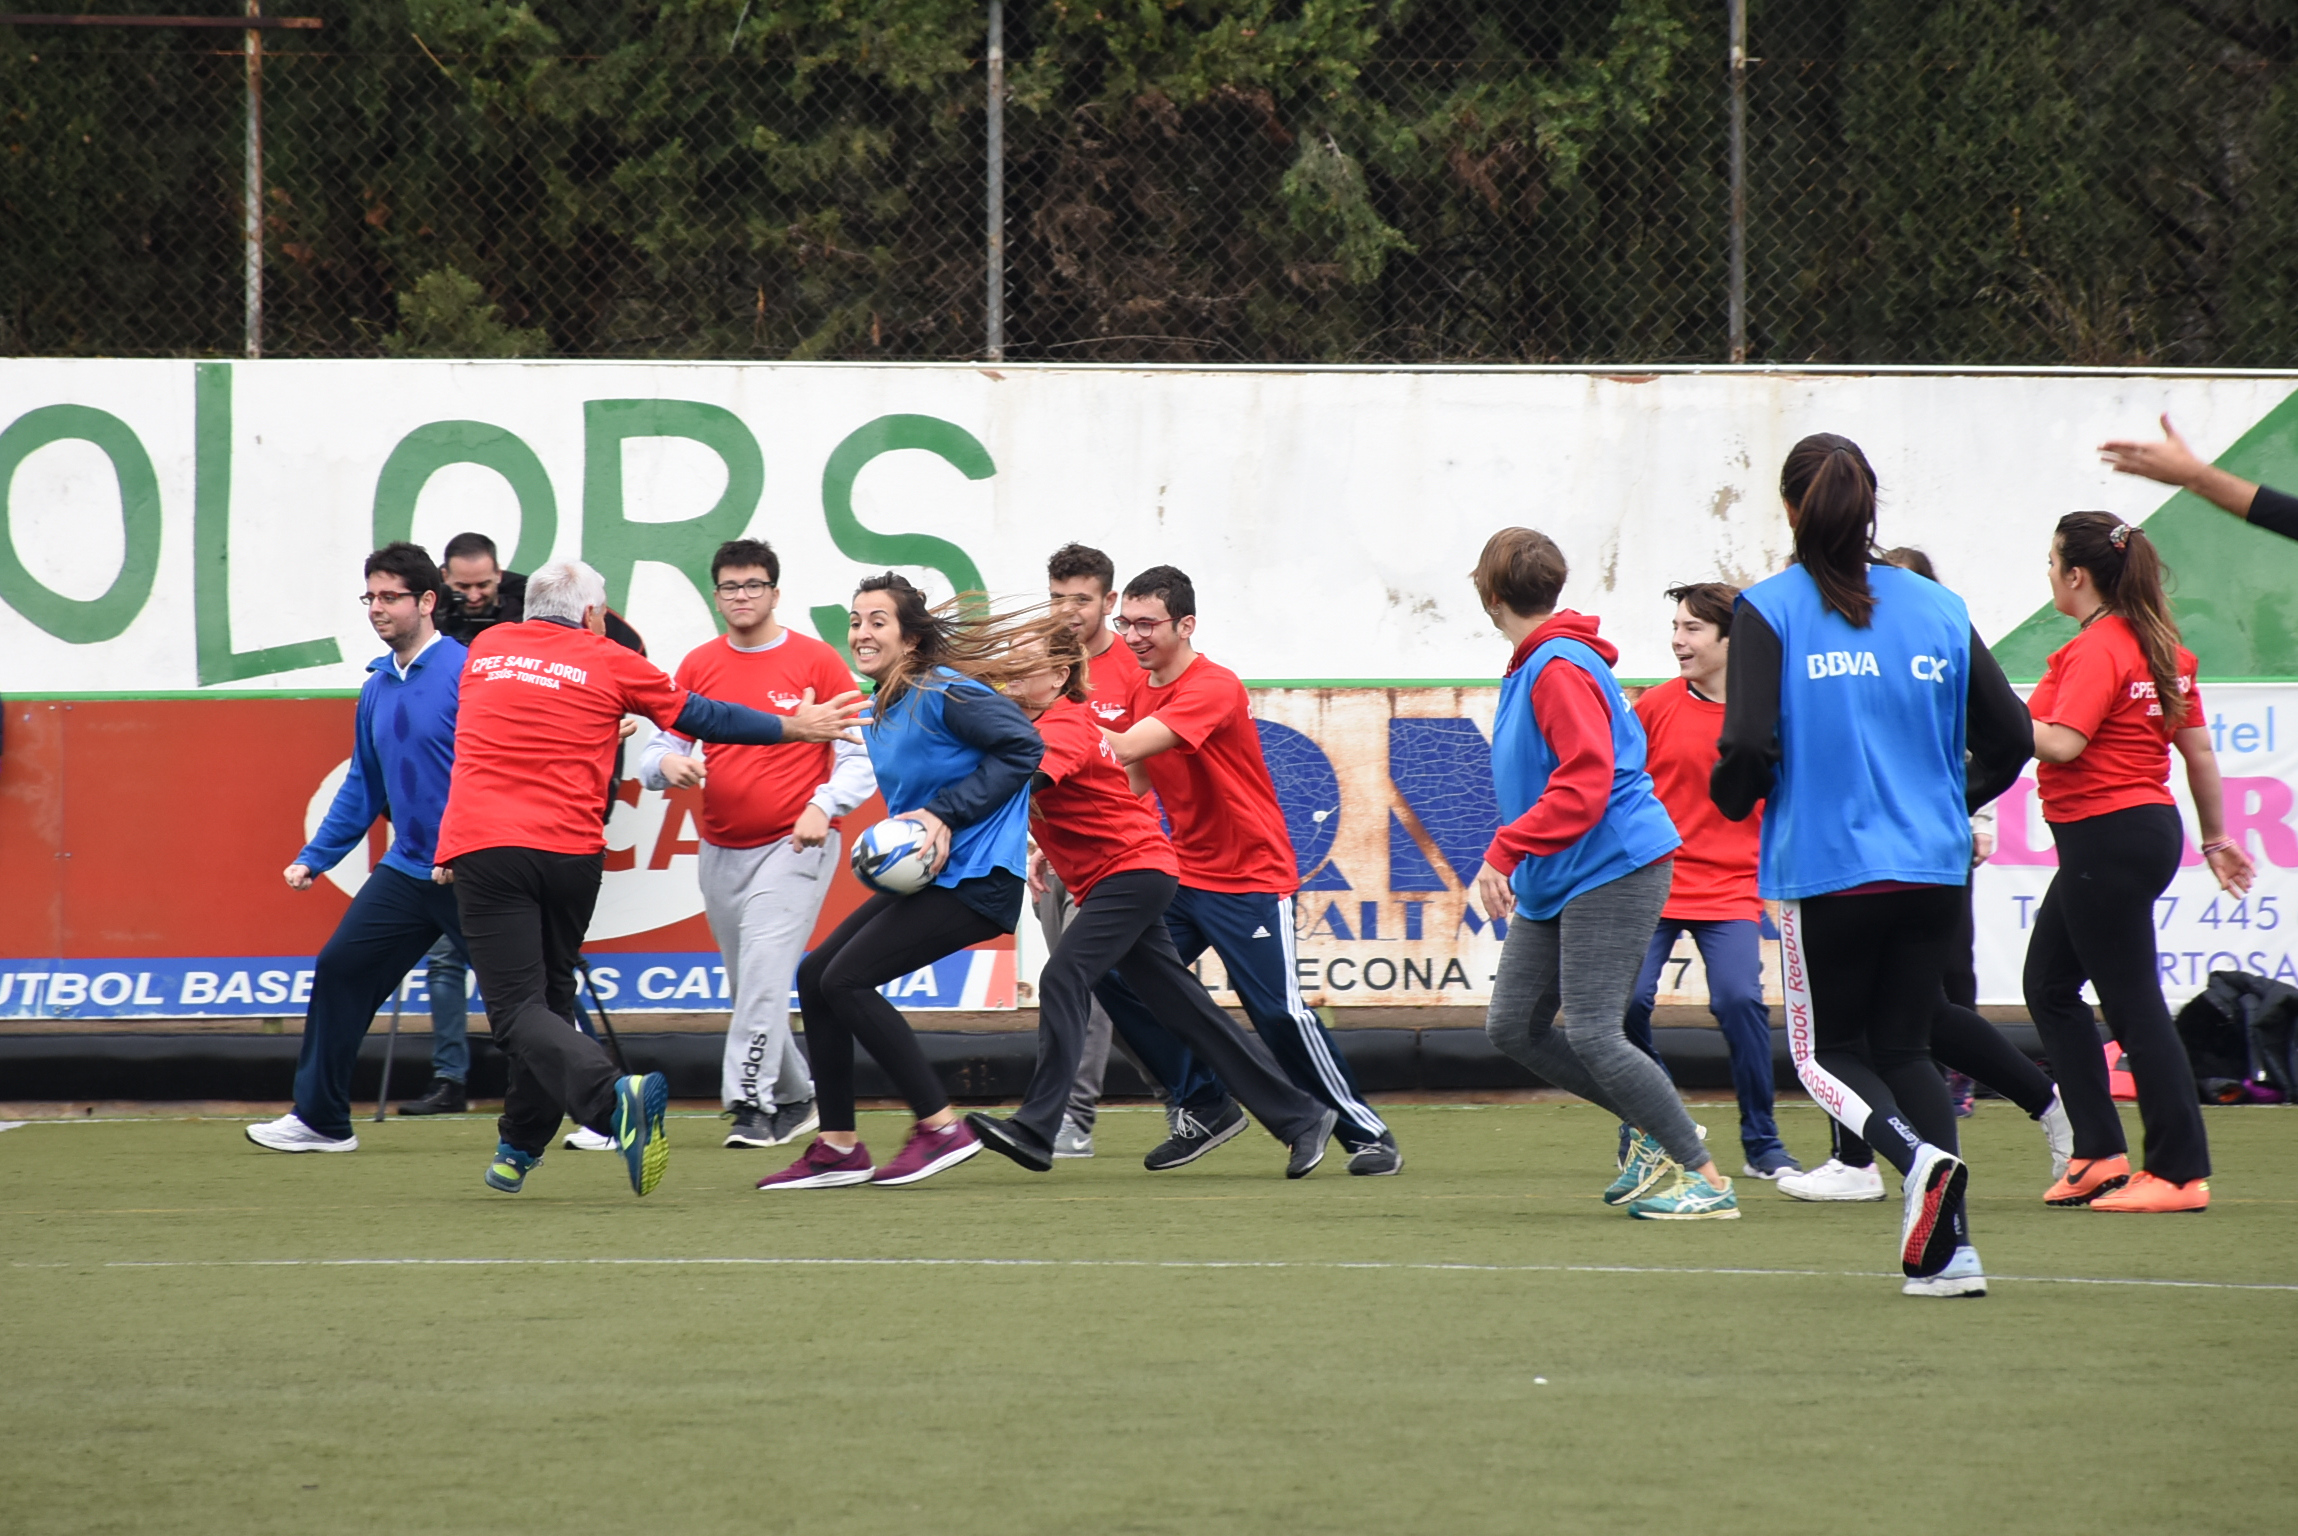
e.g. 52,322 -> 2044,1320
0,405 -> 161,646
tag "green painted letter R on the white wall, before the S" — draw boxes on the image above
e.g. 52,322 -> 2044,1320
583,400 -> 765,628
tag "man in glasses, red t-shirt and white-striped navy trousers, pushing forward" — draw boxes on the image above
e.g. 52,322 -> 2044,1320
1096,566 -> 1404,1175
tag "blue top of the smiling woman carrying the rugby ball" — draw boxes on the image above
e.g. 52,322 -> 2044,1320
862,667 -> 1046,885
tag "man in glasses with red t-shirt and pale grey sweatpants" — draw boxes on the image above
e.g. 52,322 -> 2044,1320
639,538 -> 878,1147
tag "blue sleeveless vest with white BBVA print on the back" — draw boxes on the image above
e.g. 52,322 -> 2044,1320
1733,566 -> 1972,901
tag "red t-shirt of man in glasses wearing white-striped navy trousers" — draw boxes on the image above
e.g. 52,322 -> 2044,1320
1133,655 -> 1301,897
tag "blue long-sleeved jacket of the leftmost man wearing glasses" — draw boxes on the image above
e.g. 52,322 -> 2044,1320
294,635 -> 471,881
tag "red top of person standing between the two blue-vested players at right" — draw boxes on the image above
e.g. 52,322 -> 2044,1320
1636,678 -> 1763,922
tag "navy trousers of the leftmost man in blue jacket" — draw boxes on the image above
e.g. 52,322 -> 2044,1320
294,865 -> 462,1138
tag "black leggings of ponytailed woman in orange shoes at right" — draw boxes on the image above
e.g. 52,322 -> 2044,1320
2025,805 -> 2211,1184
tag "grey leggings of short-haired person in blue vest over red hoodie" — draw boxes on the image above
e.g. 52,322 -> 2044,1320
1485,858 -> 1707,1168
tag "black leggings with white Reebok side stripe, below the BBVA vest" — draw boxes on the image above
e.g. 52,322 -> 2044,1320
1779,885 -> 1962,1173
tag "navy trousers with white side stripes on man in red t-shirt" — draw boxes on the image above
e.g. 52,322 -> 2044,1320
1094,885 -> 1388,1152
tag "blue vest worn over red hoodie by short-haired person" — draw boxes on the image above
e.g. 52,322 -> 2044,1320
1491,625 -> 1684,922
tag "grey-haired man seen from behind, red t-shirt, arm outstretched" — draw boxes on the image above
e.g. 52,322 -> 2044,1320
432,561 -> 862,1196
